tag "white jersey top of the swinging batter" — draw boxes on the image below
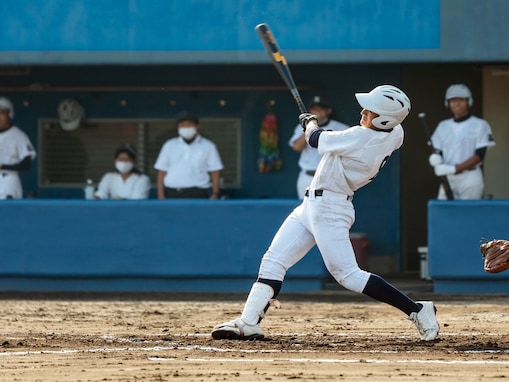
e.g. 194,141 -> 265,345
310,125 -> 404,195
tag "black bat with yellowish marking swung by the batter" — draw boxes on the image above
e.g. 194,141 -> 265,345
255,23 -> 307,113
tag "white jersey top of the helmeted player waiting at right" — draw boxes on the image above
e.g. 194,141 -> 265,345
431,116 -> 495,165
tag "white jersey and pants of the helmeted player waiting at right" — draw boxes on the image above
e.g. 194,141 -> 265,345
431,116 -> 495,200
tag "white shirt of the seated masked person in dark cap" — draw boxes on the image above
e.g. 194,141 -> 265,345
95,172 -> 150,199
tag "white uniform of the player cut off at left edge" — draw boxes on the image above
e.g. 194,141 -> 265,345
0,126 -> 36,199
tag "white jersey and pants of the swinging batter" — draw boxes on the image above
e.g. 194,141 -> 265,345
258,125 -> 404,292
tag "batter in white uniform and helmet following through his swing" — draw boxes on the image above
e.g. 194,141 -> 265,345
212,85 -> 439,341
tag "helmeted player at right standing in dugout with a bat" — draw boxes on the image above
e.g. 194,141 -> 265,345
429,84 -> 495,200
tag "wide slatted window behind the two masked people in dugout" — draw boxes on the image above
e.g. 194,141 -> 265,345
39,118 -> 241,188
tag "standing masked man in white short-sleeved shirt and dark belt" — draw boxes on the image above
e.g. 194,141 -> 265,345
154,111 -> 223,199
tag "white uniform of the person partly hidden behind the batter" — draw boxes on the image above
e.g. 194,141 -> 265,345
288,119 -> 350,199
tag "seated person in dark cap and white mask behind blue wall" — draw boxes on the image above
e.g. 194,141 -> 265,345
94,143 -> 150,199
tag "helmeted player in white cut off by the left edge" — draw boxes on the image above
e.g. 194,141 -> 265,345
0,97 -> 36,199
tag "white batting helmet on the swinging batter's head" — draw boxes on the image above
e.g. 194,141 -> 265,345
355,85 -> 411,130
